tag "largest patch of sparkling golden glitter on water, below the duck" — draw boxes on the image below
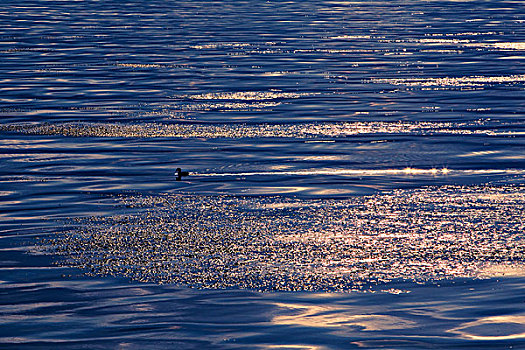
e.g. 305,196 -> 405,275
51,186 -> 525,291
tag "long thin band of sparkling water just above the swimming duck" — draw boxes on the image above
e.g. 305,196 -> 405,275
0,120 -> 522,139
